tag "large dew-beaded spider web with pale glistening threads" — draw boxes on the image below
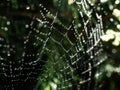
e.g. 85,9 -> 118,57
0,0 -> 104,90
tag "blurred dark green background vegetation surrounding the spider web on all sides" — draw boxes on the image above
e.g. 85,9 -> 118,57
0,0 -> 120,90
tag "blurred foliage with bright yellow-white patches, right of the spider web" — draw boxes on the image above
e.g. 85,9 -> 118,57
97,0 -> 120,90
